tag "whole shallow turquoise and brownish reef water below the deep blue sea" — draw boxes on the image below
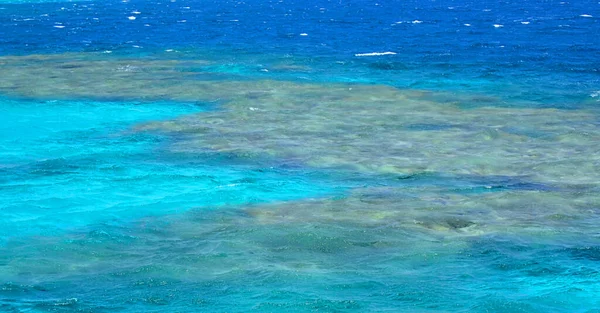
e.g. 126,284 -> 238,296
0,54 -> 600,312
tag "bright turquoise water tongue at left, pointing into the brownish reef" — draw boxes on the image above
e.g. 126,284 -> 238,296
0,99 -> 338,240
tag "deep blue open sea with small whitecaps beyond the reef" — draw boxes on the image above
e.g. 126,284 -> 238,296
0,0 -> 600,106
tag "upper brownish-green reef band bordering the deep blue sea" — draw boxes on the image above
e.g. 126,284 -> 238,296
0,54 -> 600,184
